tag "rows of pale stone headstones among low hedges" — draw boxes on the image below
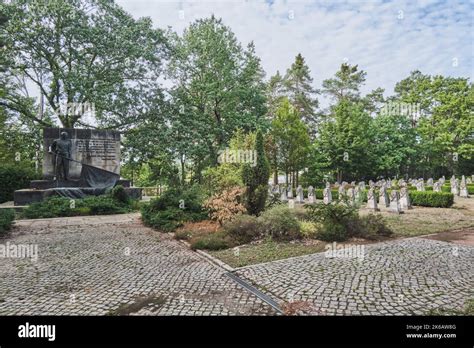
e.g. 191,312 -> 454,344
269,175 -> 474,213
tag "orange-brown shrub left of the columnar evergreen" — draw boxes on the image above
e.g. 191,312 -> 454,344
203,187 -> 246,225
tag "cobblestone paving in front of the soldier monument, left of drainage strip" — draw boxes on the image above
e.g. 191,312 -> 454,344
0,214 -> 275,315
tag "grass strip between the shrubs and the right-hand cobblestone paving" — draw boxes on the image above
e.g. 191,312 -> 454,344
209,239 -> 326,268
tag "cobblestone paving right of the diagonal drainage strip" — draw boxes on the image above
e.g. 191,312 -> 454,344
236,238 -> 474,315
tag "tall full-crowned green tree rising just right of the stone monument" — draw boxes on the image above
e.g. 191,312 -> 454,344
170,16 -> 266,173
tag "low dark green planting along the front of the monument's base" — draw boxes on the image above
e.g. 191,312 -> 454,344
21,195 -> 131,219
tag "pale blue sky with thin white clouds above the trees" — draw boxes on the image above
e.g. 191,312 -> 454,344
117,0 -> 474,104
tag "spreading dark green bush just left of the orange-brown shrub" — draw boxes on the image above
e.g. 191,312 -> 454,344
141,186 -> 207,232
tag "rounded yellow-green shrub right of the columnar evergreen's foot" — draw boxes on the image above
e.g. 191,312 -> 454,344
259,205 -> 301,241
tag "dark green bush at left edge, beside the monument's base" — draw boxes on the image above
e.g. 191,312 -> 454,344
0,164 -> 39,203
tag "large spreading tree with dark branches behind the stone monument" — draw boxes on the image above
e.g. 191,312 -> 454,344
0,0 -> 166,128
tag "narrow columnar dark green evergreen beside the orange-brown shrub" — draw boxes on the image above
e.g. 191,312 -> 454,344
242,131 -> 270,216
